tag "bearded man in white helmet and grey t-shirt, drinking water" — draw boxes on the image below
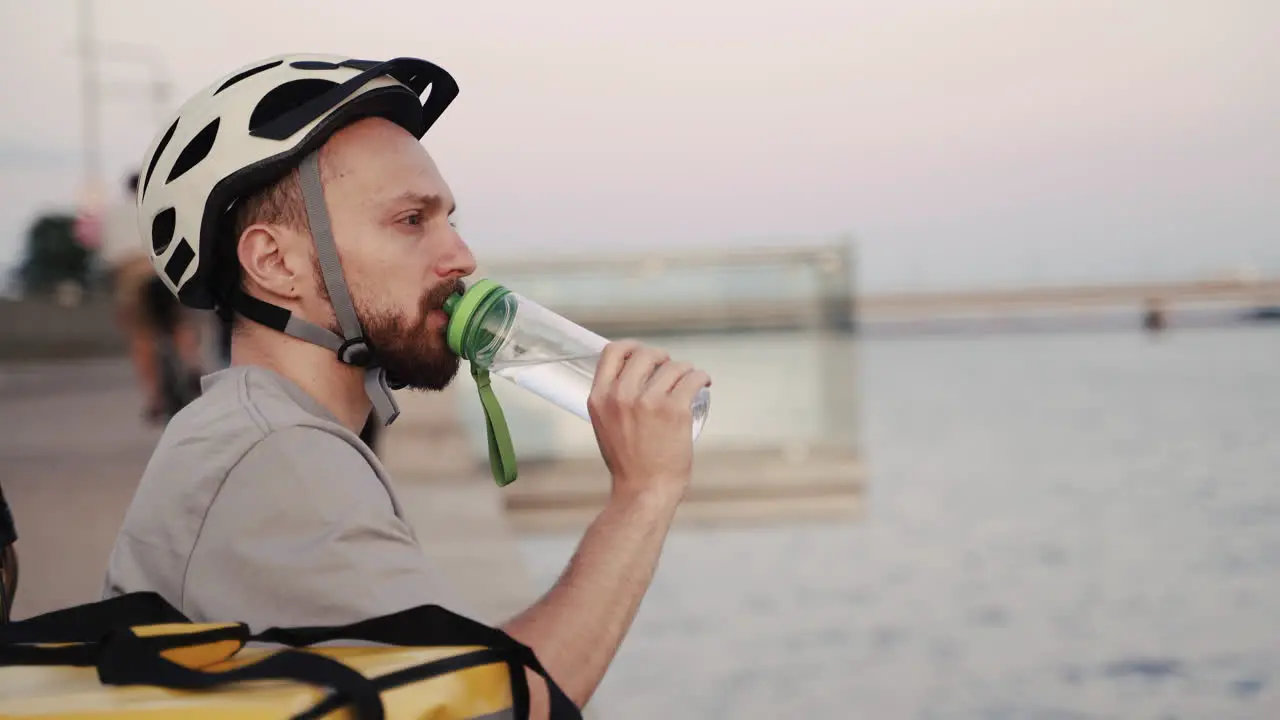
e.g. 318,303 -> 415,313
104,55 -> 710,712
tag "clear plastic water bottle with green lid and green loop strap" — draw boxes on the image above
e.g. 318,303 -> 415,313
444,279 -> 710,484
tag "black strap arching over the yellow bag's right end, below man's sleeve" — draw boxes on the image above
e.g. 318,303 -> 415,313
252,605 -> 582,720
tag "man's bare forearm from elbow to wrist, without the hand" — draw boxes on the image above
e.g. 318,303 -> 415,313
503,484 -> 678,707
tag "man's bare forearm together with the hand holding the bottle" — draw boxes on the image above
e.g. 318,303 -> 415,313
503,341 -> 710,716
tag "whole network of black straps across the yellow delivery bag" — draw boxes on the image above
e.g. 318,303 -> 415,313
0,592 -> 582,720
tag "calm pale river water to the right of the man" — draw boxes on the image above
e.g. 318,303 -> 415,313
512,328 -> 1280,720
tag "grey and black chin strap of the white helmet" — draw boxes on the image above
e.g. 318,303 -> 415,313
233,151 -> 399,425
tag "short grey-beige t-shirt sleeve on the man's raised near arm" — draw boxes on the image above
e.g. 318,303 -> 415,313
183,427 -> 456,630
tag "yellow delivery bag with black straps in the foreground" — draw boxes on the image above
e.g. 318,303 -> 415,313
0,593 -> 582,720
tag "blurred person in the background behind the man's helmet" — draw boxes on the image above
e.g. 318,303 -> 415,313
99,172 -> 202,421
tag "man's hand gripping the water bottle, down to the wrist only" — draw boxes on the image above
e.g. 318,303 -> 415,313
586,341 -> 710,502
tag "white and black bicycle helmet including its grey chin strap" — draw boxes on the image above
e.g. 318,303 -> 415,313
138,54 -> 458,424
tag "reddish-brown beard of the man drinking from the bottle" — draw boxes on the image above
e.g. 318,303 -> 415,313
321,270 -> 466,391
